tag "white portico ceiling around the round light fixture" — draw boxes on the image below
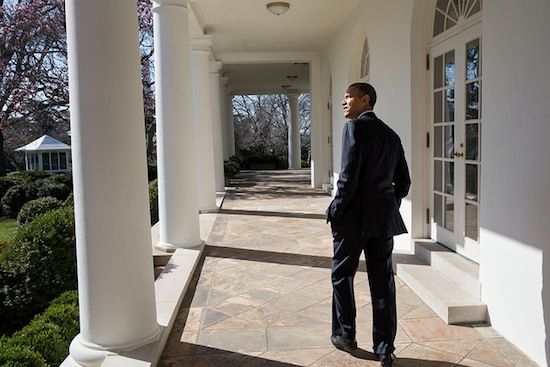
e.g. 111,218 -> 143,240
189,0 -> 361,94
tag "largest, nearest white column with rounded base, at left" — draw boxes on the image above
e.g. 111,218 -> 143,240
65,0 -> 160,366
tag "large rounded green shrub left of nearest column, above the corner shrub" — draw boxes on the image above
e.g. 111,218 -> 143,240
0,208 -> 76,330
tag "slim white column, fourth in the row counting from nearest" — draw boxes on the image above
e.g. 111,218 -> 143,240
210,62 -> 225,192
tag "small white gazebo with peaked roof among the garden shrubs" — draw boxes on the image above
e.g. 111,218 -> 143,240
16,135 -> 71,172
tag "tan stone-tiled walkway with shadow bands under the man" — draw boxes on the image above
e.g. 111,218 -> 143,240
159,170 -> 537,367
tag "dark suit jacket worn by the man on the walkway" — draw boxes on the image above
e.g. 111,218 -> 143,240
327,111 -> 411,238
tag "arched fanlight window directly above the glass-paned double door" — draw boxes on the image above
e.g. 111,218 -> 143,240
433,0 -> 483,37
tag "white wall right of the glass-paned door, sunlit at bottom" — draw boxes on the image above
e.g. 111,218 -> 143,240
480,0 -> 550,366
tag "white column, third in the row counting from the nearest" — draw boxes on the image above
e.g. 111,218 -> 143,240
191,36 -> 217,212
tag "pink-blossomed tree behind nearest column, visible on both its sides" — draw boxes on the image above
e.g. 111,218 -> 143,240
0,0 -> 155,176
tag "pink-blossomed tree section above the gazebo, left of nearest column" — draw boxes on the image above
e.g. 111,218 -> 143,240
0,0 -> 68,176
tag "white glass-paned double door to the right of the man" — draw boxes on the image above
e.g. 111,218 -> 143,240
430,24 -> 482,261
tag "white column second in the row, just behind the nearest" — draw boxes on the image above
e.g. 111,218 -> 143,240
153,0 -> 203,249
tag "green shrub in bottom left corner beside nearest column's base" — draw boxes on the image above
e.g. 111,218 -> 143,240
0,290 -> 79,367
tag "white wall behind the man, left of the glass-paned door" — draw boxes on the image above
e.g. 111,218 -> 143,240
324,0 -> 413,249
